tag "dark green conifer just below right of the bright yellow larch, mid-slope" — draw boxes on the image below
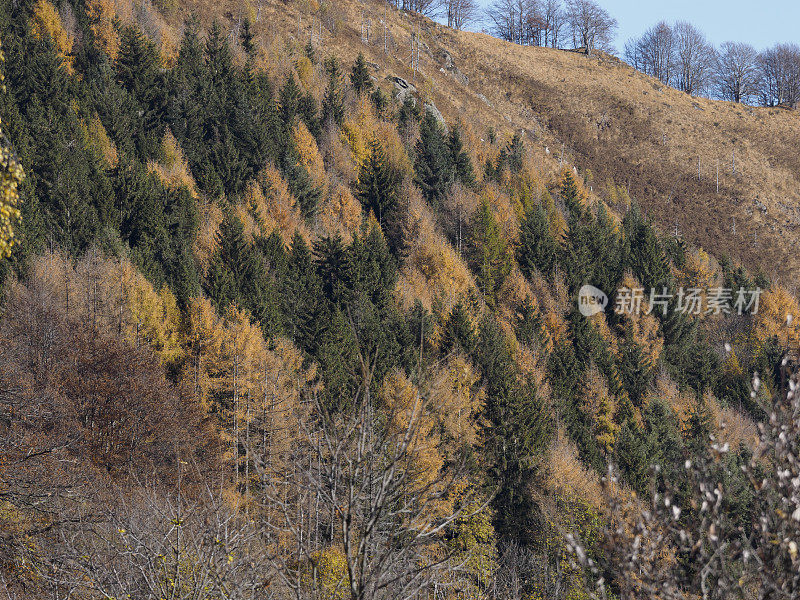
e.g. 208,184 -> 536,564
355,137 -> 402,249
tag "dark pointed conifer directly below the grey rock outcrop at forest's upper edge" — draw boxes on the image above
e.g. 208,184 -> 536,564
414,112 -> 454,207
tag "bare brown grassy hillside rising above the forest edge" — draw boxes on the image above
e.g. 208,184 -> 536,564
183,0 -> 800,282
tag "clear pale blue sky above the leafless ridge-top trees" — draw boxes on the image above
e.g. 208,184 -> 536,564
472,0 -> 800,50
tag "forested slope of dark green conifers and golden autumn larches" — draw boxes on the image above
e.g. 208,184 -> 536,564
0,0 -> 800,600
